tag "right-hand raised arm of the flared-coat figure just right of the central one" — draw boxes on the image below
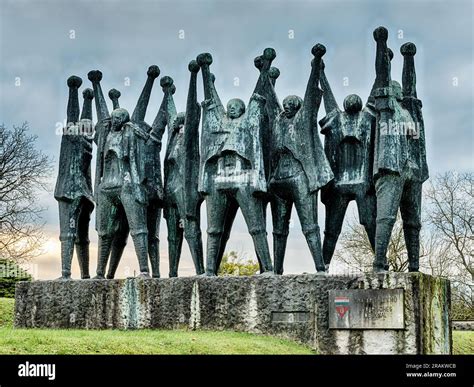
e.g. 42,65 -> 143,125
302,44 -> 326,128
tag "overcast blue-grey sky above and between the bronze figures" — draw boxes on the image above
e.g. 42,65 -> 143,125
0,0 -> 474,279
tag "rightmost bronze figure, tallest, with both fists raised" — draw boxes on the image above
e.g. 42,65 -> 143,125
374,27 -> 428,272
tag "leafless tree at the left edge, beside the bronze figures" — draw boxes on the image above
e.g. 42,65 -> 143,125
0,123 -> 52,262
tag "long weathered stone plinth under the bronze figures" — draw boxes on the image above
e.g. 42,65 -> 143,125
15,273 -> 452,354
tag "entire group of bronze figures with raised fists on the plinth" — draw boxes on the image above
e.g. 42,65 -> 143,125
55,27 -> 428,279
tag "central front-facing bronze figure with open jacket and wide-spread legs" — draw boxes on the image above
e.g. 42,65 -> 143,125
197,54 -> 273,275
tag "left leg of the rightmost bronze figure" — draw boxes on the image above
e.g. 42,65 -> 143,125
374,174 -> 403,271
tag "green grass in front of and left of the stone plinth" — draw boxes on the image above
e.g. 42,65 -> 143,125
0,298 -> 314,354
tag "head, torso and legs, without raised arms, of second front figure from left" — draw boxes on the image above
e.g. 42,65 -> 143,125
97,108 -> 150,278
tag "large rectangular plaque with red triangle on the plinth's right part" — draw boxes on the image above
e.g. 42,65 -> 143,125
329,289 -> 405,329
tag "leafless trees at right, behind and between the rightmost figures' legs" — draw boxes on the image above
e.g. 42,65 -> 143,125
334,172 -> 474,319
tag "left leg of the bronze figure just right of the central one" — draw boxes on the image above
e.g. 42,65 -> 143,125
270,196 -> 293,274
